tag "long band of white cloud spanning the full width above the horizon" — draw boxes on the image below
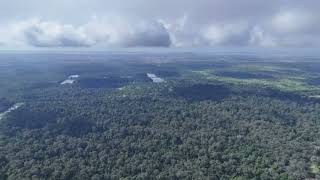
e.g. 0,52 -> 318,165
0,6 -> 320,47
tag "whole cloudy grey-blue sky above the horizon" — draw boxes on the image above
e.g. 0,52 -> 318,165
0,0 -> 320,49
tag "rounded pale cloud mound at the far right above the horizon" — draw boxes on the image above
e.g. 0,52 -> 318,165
250,9 -> 320,47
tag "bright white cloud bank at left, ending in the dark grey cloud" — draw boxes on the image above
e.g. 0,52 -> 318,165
0,19 -> 171,47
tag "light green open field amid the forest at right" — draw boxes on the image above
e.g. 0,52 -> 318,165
192,64 -> 320,97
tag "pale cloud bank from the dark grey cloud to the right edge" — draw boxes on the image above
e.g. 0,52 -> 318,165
161,9 -> 320,47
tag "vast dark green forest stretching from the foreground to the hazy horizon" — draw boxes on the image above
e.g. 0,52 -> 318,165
0,51 -> 320,180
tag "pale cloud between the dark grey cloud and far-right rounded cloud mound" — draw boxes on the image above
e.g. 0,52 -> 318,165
160,15 -> 249,47
